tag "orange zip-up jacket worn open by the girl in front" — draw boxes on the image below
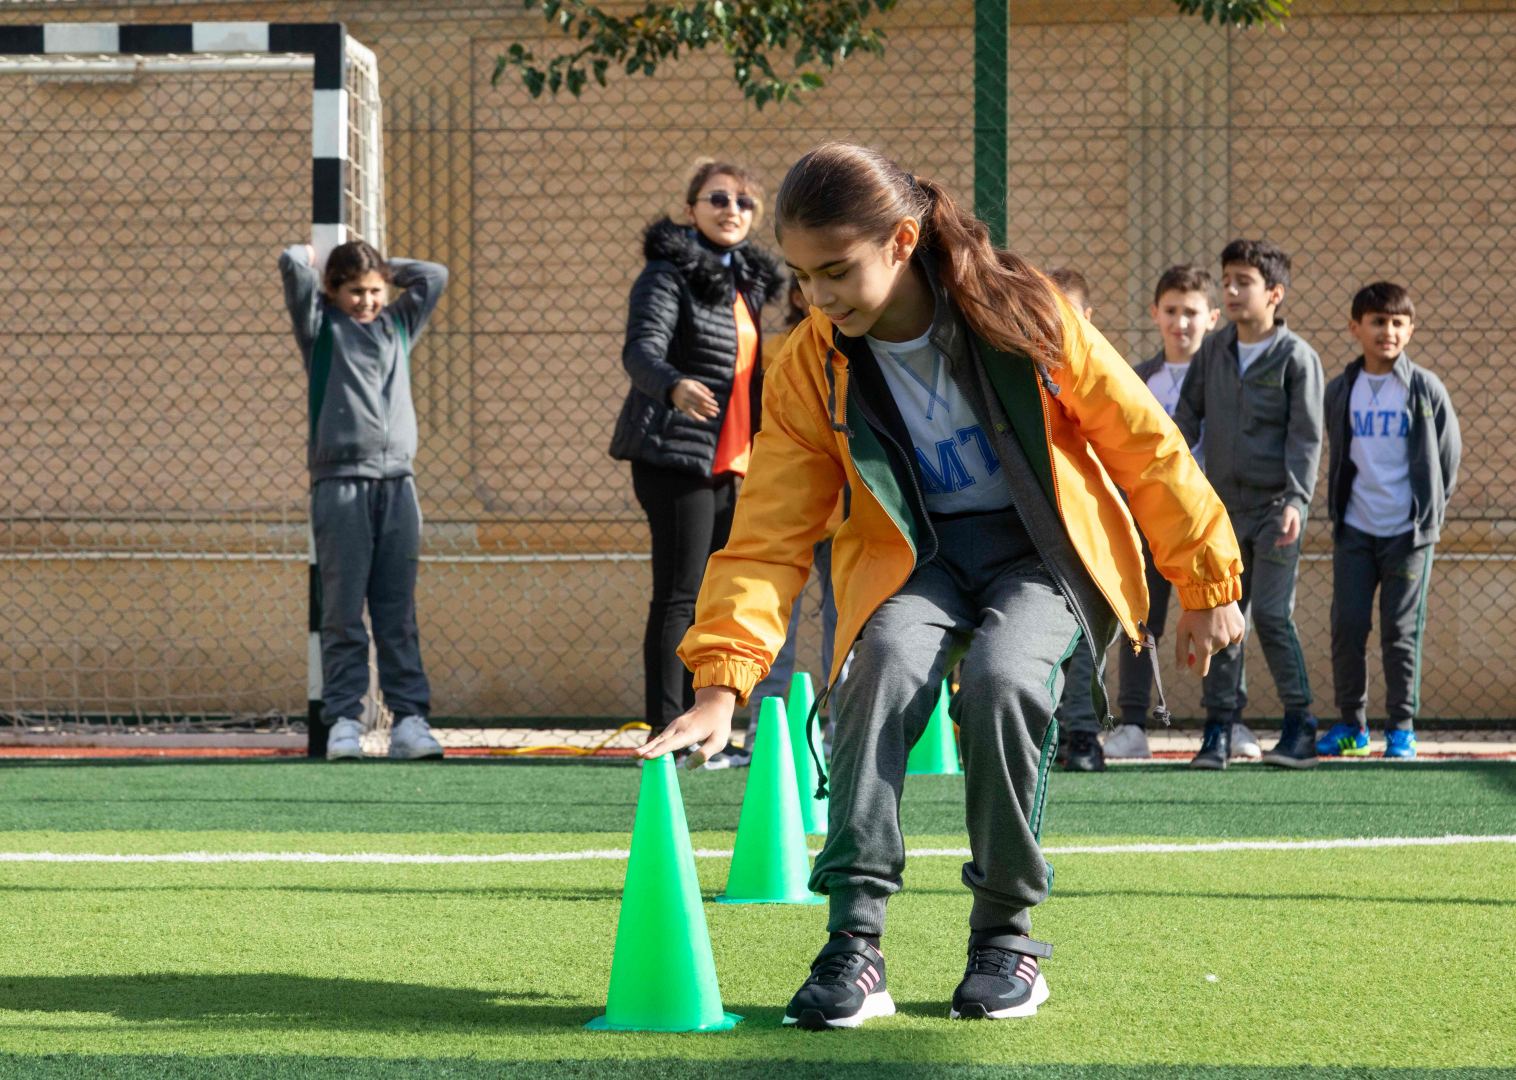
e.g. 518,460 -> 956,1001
679,297 -> 1242,701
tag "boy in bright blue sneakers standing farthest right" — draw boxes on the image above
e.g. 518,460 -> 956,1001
1316,281 -> 1463,758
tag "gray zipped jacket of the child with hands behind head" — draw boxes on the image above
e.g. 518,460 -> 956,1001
279,244 -> 447,482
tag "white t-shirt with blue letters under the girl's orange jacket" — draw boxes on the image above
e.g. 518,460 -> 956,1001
866,332 -> 1011,514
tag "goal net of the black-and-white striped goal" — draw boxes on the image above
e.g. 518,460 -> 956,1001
0,24 -> 385,734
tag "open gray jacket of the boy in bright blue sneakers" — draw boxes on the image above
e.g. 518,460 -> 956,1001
1327,352 -> 1463,548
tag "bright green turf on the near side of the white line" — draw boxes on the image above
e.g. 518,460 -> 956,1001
0,845 -> 1516,1075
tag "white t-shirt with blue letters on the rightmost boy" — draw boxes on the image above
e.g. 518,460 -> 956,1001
1343,372 -> 1411,537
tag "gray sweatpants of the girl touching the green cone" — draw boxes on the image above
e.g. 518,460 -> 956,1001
811,511 -> 1081,934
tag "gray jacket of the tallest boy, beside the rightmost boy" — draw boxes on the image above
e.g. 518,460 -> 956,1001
1173,320 -> 1325,516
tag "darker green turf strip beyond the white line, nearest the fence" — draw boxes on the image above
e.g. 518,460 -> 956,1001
0,760 -> 1516,837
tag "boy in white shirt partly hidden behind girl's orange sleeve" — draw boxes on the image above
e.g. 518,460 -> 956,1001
1105,264 -> 1263,761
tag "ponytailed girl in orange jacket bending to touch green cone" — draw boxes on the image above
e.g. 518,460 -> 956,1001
640,143 -> 1243,1028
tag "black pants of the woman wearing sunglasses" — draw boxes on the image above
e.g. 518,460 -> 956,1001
632,461 -> 737,734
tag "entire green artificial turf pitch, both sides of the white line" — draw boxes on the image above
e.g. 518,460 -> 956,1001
0,763 -> 1516,1080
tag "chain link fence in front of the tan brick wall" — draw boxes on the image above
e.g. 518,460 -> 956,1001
0,0 -> 1516,728
